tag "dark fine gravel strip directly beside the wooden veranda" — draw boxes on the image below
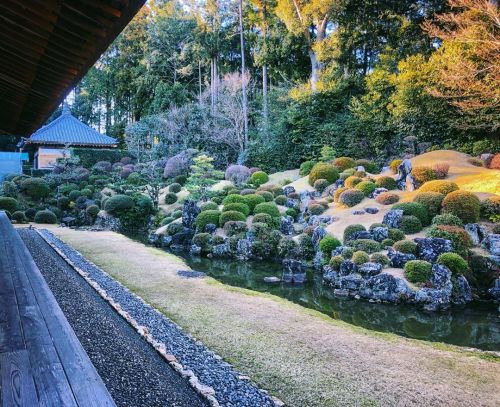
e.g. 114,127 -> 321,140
19,229 -> 207,407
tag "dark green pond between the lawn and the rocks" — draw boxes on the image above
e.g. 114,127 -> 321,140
175,251 -> 500,351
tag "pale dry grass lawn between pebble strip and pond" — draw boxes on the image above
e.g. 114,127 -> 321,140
45,227 -> 500,407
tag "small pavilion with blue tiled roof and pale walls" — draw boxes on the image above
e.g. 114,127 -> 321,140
26,104 -> 118,170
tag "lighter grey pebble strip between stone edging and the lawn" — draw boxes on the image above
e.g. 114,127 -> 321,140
28,230 -> 275,407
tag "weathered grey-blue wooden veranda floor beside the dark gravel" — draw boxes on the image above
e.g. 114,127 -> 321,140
0,212 -> 115,406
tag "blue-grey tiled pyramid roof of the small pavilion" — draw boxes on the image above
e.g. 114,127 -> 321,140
28,107 -> 117,146
